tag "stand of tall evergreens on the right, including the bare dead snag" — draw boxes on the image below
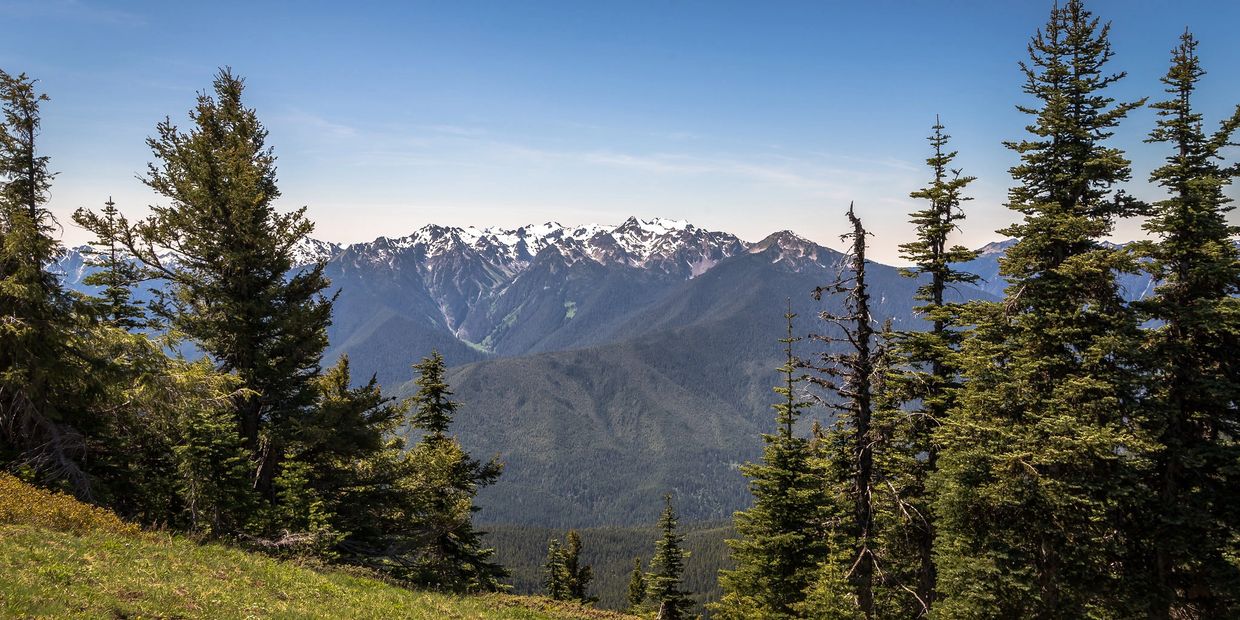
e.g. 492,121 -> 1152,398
714,0 -> 1240,619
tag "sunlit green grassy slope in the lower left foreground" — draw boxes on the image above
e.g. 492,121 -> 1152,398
0,477 -> 627,620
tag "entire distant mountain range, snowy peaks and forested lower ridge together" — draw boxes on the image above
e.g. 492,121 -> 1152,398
53,218 -> 1148,527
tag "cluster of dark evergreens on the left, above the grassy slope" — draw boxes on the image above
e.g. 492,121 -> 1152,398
0,69 -> 506,590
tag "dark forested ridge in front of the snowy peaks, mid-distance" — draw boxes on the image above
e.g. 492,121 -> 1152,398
394,242 -> 983,527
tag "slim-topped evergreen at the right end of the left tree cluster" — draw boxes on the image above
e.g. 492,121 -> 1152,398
403,352 -> 507,591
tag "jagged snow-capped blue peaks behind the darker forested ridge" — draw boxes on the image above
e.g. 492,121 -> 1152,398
310,217 -> 749,360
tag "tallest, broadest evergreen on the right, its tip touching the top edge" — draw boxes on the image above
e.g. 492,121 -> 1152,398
935,0 -> 1149,618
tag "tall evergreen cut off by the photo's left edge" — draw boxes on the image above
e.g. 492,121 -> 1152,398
0,71 -> 99,497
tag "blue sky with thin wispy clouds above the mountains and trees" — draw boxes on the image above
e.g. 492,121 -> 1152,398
0,0 -> 1240,262
